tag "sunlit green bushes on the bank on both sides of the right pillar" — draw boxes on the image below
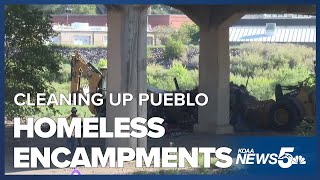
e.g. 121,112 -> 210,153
148,43 -> 315,100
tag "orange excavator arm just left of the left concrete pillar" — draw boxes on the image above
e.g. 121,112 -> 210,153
70,52 -> 103,114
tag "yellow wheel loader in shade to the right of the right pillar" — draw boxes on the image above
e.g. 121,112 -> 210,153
230,82 -> 315,131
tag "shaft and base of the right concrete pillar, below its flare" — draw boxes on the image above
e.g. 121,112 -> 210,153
194,25 -> 233,134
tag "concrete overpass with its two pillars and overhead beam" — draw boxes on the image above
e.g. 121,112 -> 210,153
106,5 -> 316,148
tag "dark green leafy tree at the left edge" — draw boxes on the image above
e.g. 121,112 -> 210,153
5,5 -> 62,117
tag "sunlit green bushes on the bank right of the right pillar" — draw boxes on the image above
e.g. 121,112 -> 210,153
230,43 -> 315,100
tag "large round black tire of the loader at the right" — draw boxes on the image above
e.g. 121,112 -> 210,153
270,99 -> 300,131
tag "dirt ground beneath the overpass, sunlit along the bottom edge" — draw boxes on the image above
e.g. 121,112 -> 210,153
5,125 -> 292,175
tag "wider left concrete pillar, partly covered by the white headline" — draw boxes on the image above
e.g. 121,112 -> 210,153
106,5 -> 147,148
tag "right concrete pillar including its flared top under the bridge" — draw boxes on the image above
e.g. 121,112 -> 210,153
175,5 -> 245,134
